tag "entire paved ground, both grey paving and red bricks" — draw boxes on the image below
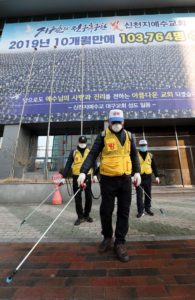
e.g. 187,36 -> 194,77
0,189 -> 195,300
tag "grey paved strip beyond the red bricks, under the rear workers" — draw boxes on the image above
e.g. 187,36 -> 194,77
0,186 -> 195,243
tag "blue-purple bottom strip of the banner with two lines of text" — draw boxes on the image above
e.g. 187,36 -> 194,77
0,90 -> 195,123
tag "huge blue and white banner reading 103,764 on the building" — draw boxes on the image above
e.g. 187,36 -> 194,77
0,14 -> 195,124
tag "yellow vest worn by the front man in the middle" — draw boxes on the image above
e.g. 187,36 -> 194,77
100,128 -> 132,176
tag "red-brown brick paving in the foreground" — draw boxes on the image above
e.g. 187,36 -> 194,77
0,240 -> 195,300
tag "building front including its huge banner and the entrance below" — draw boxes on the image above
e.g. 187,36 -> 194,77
0,3 -> 195,186
